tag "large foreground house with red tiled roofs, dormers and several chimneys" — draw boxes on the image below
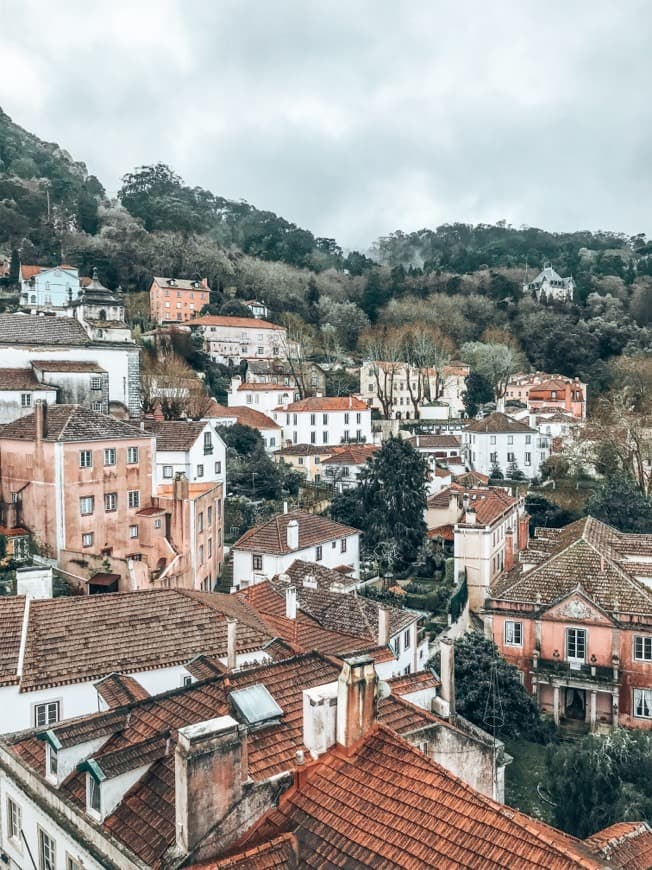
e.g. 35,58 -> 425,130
0,653 -> 652,870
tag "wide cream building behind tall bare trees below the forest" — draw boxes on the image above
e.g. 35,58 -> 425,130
360,360 -> 471,420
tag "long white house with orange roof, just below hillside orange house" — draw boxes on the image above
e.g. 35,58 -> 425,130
190,314 -> 287,365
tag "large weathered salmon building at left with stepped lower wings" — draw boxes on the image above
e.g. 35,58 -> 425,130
0,402 -> 223,593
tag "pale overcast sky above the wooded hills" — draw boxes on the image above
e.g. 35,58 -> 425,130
0,0 -> 652,248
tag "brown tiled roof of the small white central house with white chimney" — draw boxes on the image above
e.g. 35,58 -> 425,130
232,511 -> 359,555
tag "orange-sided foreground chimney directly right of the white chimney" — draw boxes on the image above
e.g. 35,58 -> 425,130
337,655 -> 377,749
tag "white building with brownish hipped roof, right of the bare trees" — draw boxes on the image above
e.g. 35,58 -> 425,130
462,411 -> 550,480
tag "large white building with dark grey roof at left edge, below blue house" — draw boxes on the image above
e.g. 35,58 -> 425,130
0,314 -> 140,417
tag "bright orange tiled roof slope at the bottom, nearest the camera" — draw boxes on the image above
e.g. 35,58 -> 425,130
251,724 -> 600,870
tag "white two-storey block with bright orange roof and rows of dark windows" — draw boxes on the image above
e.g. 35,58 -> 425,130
274,396 -> 372,446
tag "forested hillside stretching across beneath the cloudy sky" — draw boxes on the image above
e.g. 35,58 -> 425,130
0,106 -> 652,395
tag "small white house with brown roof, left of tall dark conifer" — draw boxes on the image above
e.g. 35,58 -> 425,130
231,511 -> 360,590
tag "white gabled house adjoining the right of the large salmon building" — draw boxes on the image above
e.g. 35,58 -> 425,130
145,420 -> 226,492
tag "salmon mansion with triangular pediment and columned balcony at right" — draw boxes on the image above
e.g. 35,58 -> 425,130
482,517 -> 652,731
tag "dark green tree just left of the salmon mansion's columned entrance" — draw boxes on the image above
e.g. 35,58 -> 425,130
429,631 -> 552,743
